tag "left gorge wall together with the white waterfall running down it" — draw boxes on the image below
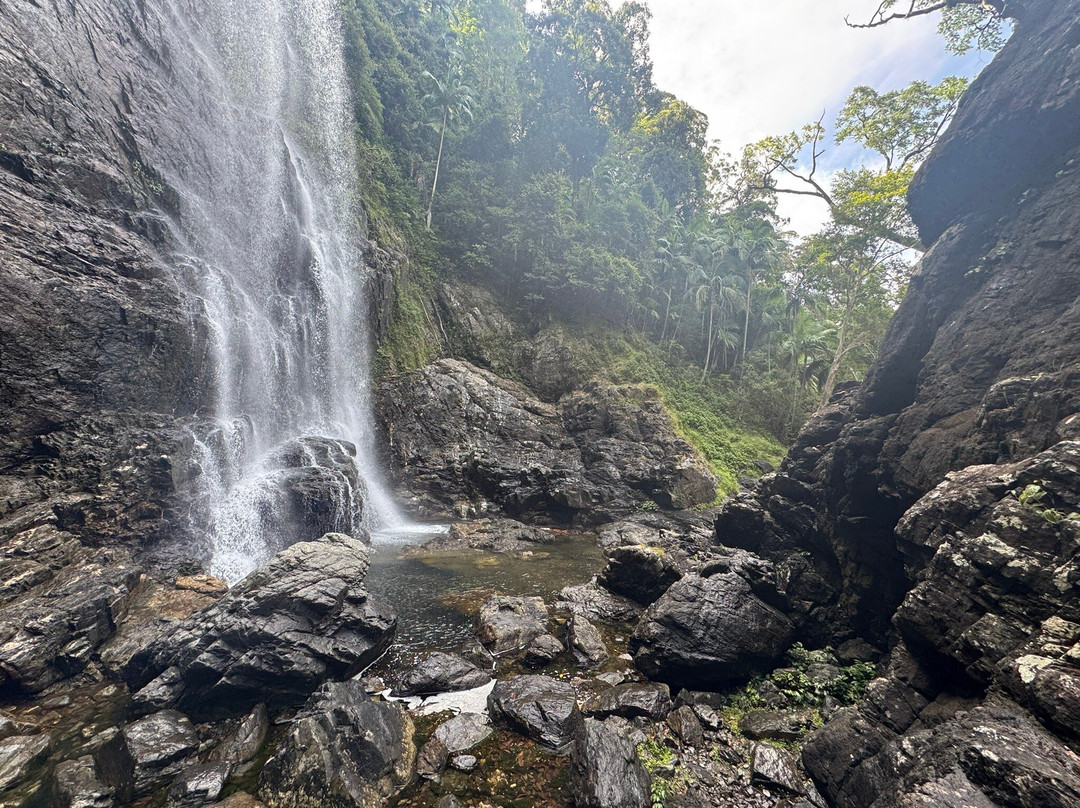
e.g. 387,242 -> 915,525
0,0 -> 401,577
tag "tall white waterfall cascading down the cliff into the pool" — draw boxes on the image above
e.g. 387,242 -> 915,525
158,0 -> 403,582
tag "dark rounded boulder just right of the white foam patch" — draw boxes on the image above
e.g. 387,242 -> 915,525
487,676 -> 579,750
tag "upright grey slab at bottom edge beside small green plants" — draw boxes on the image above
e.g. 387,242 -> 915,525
570,717 -> 652,808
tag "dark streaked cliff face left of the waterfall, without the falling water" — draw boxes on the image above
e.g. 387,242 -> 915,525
0,1 -> 206,542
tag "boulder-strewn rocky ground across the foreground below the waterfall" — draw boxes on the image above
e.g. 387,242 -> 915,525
0,507 -> 878,808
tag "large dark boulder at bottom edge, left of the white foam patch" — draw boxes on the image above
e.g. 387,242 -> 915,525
258,682 -> 416,808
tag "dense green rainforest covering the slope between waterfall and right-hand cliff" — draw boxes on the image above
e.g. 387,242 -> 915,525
342,0 -> 980,445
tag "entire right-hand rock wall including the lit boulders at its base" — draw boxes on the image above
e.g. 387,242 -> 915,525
716,0 -> 1080,808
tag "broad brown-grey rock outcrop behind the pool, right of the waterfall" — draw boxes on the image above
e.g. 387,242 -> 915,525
376,360 -> 716,522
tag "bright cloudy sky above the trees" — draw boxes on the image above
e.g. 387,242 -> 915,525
529,0 -> 989,234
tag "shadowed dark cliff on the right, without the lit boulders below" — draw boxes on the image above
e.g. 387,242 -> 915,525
717,2 -> 1080,635
